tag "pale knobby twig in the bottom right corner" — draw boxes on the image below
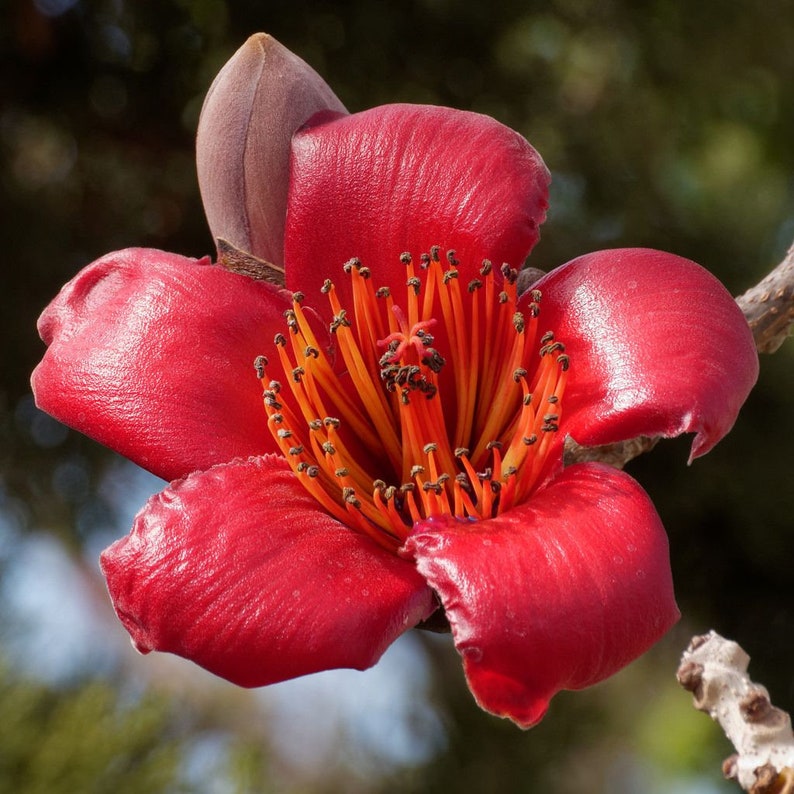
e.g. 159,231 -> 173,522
677,631 -> 794,794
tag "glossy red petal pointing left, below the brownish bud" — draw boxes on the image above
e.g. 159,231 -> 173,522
32,249 -> 290,479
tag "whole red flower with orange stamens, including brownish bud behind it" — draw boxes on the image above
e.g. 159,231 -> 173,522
33,35 -> 758,727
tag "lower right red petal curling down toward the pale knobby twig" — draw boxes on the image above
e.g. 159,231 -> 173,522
405,464 -> 678,728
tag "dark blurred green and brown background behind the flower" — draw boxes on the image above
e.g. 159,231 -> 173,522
0,0 -> 794,794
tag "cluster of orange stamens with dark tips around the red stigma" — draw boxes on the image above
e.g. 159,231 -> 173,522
255,247 -> 569,550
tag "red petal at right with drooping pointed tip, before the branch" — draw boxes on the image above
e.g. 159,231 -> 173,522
535,248 -> 758,458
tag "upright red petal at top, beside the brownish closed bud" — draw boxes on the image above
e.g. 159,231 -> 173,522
285,105 -> 549,300
